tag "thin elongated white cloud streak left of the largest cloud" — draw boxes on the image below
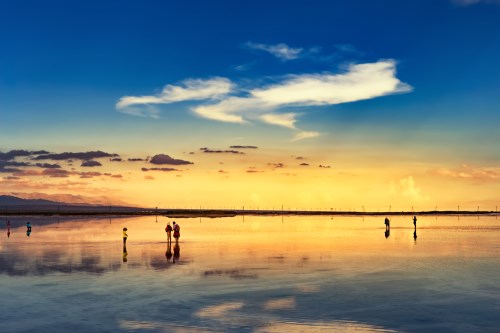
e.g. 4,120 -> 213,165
116,77 -> 233,108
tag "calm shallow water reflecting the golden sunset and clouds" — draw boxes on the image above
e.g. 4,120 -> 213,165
0,216 -> 500,332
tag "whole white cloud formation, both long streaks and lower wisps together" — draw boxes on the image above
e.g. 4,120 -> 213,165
116,59 -> 412,140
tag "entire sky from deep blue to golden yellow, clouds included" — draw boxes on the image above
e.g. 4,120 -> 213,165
0,0 -> 500,211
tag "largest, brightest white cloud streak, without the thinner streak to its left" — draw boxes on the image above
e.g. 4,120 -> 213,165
193,60 -> 412,126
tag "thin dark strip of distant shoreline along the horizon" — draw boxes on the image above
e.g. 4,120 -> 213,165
0,207 -> 500,218
